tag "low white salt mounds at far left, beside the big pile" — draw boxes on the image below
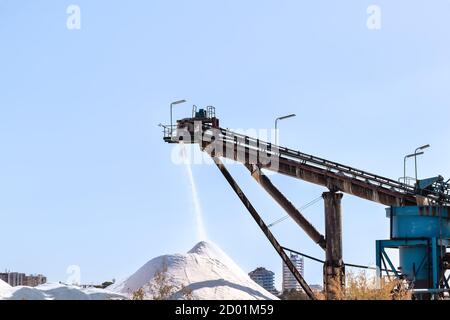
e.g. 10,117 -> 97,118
0,284 -> 126,300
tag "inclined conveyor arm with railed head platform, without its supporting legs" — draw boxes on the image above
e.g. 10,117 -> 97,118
163,111 -> 450,206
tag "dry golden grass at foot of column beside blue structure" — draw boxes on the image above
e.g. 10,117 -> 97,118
318,272 -> 411,300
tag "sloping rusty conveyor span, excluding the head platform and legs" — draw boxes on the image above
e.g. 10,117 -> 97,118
201,126 -> 426,206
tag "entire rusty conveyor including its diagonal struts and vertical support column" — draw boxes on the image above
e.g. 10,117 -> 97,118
163,107 -> 450,299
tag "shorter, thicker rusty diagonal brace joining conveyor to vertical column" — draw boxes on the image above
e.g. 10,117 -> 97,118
245,164 -> 326,249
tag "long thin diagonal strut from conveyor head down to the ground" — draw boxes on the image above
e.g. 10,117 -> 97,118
211,155 -> 317,300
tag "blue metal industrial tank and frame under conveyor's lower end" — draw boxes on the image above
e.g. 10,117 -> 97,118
376,206 -> 450,299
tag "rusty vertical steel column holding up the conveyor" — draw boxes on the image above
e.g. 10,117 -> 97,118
323,192 -> 345,300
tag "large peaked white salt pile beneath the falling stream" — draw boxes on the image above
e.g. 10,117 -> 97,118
108,242 -> 277,300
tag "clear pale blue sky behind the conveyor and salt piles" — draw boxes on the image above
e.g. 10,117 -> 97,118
0,0 -> 450,290
